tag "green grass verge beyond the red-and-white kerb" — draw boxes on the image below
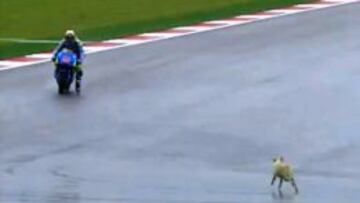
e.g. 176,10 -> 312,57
0,0 -> 314,58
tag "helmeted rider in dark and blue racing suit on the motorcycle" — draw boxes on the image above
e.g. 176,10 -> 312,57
52,30 -> 84,92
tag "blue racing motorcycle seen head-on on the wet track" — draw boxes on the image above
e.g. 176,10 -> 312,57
54,49 -> 79,94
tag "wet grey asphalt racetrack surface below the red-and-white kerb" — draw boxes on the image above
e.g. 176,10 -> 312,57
0,3 -> 360,203
